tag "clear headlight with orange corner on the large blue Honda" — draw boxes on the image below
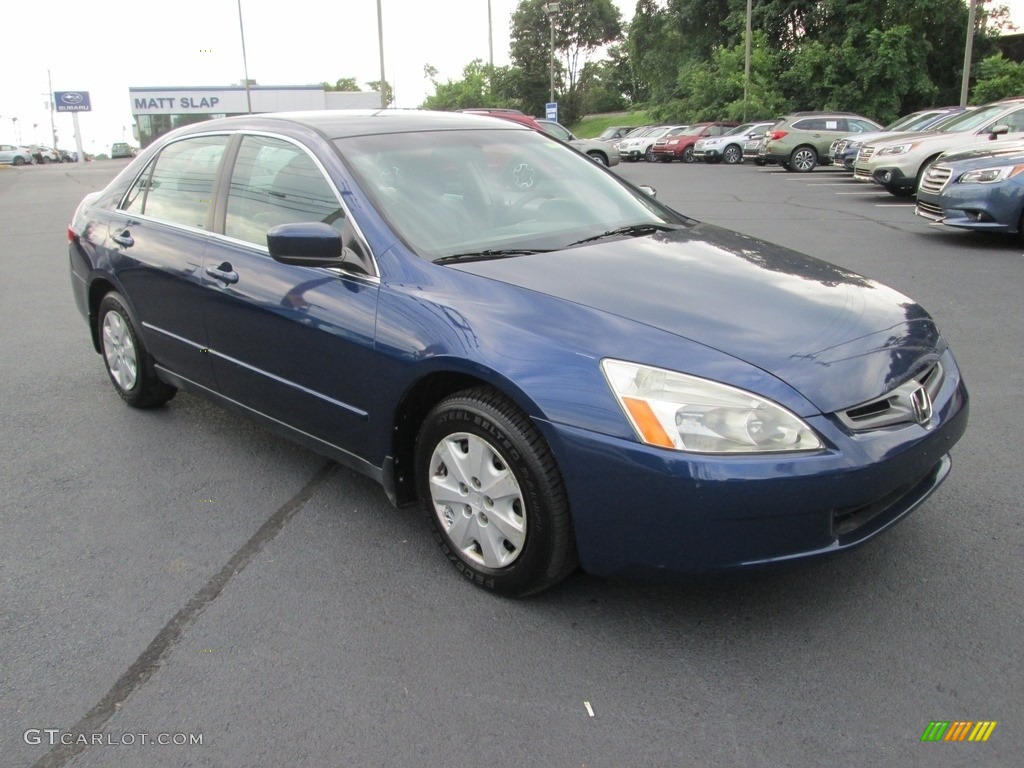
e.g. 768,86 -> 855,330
601,359 -> 822,454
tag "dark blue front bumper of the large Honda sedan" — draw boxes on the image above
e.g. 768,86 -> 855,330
540,352 -> 969,578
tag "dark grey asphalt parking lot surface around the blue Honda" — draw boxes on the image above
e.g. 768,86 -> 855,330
0,161 -> 1024,768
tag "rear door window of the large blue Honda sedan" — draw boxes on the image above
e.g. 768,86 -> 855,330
121,136 -> 227,229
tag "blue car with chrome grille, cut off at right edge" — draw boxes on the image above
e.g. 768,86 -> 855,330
914,143 -> 1024,237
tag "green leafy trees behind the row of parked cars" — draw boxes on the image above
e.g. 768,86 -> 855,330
419,0 -> 1024,124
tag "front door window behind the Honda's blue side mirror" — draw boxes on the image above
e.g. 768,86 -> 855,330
224,136 -> 344,247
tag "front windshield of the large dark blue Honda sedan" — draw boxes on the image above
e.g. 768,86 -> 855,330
335,126 -> 690,260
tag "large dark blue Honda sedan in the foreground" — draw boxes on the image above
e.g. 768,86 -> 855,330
69,111 -> 968,595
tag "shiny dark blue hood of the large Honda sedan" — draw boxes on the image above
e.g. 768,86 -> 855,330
454,224 -> 943,413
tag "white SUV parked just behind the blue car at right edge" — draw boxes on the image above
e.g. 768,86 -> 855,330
853,98 -> 1024,198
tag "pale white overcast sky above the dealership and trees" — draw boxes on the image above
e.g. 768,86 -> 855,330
0,0 -> 1024,153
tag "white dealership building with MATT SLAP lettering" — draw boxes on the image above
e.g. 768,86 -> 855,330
128,84 -> 381,146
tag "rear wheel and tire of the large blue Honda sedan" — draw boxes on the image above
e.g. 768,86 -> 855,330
96,292 -> 177,408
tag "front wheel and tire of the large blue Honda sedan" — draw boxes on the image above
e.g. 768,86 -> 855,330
416,387 -> 578,597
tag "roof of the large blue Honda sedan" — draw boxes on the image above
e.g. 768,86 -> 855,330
165,110 -> 531,139
